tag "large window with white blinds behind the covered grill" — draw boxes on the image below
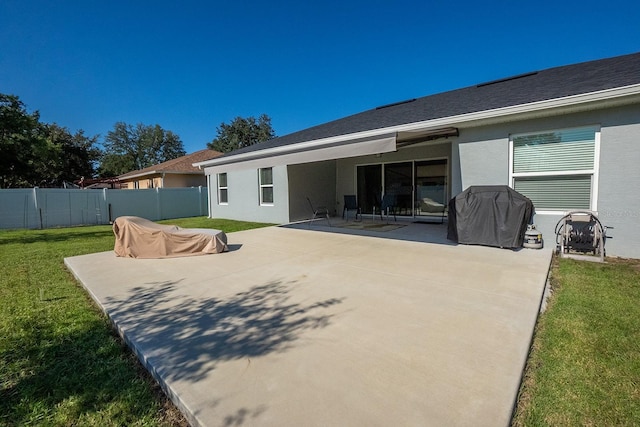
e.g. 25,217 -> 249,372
511,128 -> 596,210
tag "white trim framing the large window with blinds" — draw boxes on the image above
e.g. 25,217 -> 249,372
509,125 -> 601,215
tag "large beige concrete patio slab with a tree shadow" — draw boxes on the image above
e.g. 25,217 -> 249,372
65,227 -> 551,426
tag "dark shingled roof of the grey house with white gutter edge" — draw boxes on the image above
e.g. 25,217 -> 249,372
198,53 -> 640,171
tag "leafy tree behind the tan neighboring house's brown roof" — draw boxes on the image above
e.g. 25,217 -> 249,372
99,122 -> 186,177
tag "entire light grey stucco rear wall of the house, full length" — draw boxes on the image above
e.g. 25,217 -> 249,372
201,105 -> 640,258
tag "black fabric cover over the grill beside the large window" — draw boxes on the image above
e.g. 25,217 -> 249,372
447,185 -> 534,248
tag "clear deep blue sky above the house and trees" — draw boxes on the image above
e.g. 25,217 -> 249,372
0,0 -> 640,152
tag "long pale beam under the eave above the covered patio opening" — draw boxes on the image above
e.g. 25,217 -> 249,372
204,134 -> 396,175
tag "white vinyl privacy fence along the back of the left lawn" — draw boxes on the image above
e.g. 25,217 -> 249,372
0,187 -> 208,228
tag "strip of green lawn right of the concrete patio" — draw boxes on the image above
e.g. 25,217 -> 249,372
513,259 -> 640,426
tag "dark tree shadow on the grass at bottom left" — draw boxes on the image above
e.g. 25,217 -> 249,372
0,319 -> 159,425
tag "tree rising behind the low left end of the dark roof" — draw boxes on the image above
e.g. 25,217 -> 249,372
207,114 -> 276,153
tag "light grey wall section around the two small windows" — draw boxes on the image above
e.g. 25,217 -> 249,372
209,166 -> 289,224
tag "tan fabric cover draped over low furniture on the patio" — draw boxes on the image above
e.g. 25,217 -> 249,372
113,216 -> 227,258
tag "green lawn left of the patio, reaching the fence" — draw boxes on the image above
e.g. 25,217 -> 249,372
0,217 -> 266,426
